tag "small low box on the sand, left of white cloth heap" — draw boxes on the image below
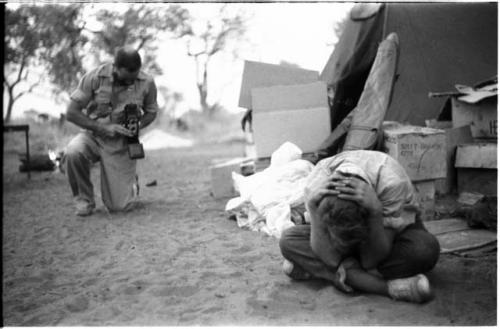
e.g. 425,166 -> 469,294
210,158 -> 249,199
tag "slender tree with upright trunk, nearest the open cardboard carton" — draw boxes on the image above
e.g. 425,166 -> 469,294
178,5 -> 246,114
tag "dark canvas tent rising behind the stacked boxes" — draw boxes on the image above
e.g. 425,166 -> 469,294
320,3 -> 498,130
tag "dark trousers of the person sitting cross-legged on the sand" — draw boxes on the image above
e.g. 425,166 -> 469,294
279,221 -> 440,280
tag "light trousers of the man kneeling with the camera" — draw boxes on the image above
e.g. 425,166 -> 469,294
63,131 -> 136,211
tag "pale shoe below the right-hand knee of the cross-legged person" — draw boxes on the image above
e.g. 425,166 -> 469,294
387,274 -> 434,303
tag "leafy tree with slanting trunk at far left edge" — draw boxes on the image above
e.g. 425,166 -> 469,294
4,4 -> 88,122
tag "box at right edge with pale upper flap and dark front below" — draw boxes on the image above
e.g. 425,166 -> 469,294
455,143 -> 498,195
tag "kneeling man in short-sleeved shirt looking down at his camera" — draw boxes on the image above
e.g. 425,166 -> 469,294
63,47 -> 158,216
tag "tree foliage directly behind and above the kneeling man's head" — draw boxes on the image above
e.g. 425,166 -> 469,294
89,5 -> 188,74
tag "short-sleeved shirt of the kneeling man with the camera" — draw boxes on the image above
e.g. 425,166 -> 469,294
70,63 -> 158,119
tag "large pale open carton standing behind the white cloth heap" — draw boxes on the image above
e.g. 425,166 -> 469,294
252,82 -> 330,158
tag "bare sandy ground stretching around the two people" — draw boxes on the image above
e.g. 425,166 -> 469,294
3,140 -> 497,326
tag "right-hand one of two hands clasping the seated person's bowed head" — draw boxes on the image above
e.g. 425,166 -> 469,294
332,175 -> 382,215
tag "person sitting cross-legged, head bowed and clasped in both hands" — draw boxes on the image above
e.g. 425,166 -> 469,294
280,150 -> 440,303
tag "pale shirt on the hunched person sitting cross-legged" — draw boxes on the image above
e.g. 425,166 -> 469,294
306,150 -> 418,231
